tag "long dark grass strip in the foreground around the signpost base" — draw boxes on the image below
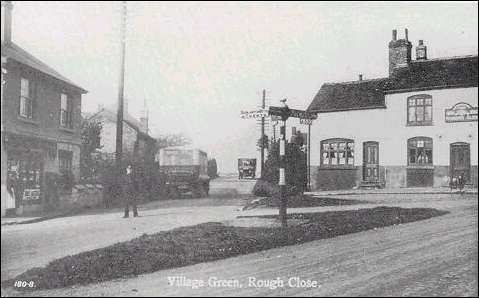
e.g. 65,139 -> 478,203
7,207 -> 447,289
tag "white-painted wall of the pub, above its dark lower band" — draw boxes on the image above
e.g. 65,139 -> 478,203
311,87 -> 478,166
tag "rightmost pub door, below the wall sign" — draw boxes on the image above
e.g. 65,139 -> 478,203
450,142 -> 471,183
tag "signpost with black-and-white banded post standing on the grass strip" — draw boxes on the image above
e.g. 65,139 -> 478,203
269,99 -> 318,228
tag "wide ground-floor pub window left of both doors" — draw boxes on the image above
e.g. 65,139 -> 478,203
321,139 -> 354,167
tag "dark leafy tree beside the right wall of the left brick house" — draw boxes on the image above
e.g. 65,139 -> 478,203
80,119 -> 102,179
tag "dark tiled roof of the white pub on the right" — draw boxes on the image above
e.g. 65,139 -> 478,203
308,55 -> 478,112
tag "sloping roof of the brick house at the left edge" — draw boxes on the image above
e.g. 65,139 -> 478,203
2,42 -> 87,93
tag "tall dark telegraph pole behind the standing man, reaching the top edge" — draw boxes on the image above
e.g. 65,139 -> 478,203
115,1 -> 126,178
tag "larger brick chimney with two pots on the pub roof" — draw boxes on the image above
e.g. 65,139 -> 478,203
389,29 -> 412,76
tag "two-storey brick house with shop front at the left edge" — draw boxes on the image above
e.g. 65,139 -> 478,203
1,1 -> 87,215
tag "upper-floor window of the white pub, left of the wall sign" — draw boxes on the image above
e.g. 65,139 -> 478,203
407,94 -> 432,125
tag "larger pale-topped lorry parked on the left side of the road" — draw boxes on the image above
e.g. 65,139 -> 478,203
156,146 -> 210,197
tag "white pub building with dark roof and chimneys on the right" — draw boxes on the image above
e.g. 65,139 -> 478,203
308,29 -> 478,190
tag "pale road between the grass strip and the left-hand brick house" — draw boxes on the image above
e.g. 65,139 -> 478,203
1,177 -> 254,281
